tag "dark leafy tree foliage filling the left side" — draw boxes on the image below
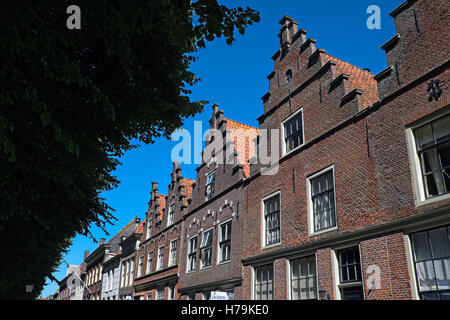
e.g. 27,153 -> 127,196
0,0 -> 259,299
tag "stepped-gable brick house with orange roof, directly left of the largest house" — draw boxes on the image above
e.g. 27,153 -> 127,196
179,105 -> 258,300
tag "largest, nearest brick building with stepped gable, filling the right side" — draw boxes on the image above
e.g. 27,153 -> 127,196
242,0 -> 450,299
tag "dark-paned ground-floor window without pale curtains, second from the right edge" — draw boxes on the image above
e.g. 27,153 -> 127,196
338,246 -> 364,300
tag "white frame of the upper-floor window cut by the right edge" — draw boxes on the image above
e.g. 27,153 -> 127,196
405,108 -> 450,206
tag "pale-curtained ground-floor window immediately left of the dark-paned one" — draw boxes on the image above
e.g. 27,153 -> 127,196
291,256 -> 317,300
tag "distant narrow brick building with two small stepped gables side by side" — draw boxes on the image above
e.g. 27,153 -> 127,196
135,163 -> 194,300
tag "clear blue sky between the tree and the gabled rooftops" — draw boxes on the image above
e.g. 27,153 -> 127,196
41,0 -> 403,297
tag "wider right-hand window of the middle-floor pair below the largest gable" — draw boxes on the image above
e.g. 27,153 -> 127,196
310,170 -> 336,232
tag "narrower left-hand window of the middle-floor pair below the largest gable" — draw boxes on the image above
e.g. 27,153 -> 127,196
264,194 -> 281,246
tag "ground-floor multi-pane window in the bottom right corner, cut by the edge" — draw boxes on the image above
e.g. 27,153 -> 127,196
411,226 -> 450,300
